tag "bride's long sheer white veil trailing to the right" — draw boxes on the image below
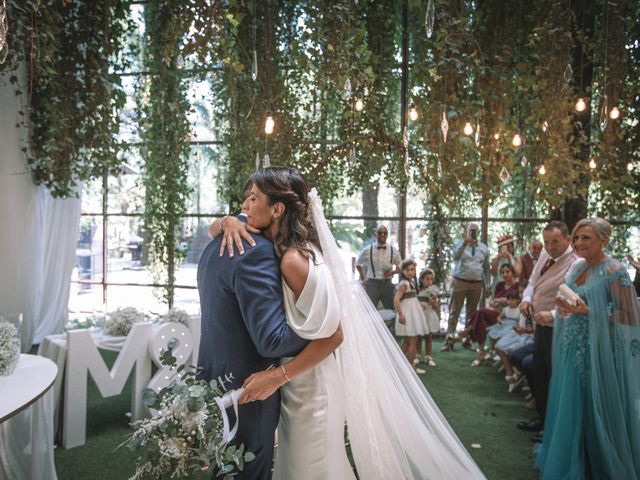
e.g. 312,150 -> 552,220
309,188 -> 485,480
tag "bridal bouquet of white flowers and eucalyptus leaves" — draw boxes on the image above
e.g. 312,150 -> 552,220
126,351 -> 255,480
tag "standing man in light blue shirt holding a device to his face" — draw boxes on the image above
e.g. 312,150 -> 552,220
441,223 -> 491,352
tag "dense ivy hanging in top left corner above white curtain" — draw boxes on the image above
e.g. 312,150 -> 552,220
0,0 -> 130,197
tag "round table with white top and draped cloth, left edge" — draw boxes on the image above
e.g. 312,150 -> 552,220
0,354 -> 58,480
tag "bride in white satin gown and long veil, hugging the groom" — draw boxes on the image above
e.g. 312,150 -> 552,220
213,167 -> 485,480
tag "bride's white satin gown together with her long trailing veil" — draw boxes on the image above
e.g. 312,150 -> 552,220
274,189 -> 485,480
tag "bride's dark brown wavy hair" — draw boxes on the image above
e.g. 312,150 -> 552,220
251,167 -> 321,261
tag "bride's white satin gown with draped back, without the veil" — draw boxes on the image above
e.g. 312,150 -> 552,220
273,252 -> 355,480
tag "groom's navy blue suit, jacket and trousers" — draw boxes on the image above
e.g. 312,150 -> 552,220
198,230 -> 307,480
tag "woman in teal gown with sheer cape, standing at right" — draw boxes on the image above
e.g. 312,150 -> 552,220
537,218 -> 640,480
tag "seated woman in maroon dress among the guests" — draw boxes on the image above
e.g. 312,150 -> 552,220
455,263 -> 520,367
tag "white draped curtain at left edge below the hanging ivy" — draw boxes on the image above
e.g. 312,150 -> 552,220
0,69 -> 80,351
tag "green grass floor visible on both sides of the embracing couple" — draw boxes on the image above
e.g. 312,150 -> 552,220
55,342 -> 537,480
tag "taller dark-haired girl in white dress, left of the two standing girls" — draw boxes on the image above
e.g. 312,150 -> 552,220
395,258 -> 429,374
